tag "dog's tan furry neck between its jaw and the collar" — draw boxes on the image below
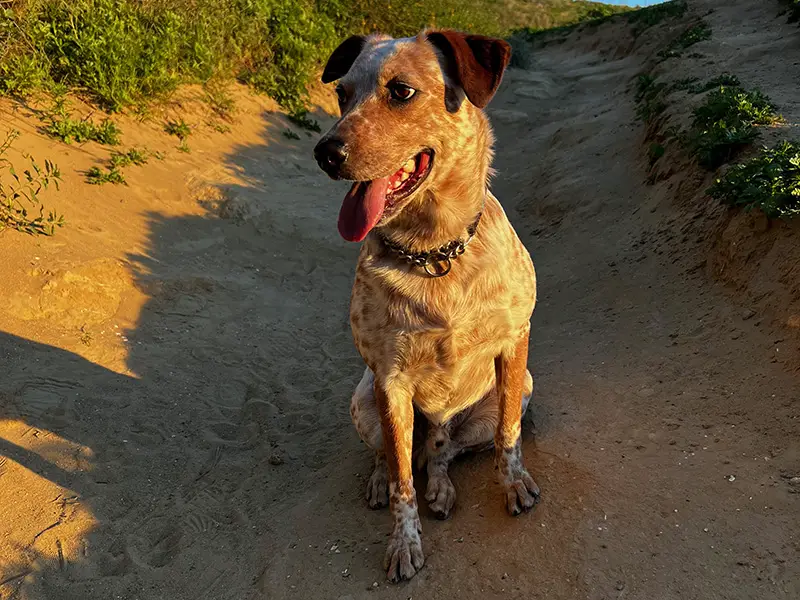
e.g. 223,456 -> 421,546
380,120 -> 492,252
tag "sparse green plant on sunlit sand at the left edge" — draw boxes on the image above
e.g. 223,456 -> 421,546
0,131 -> 64,235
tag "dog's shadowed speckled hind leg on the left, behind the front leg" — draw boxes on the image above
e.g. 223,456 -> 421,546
350,367 -> 389,509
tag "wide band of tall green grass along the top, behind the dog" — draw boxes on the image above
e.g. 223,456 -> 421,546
0,0 -> 620,113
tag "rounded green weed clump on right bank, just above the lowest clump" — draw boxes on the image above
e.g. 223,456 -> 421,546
689,86 -> 780,170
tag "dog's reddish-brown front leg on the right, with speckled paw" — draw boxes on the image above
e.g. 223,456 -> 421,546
494,330 -> 539,515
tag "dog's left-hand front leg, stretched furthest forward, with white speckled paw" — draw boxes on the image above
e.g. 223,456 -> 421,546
375,377 -> 425,581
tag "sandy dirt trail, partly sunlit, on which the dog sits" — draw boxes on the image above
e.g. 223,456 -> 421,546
0,0 -> 800,600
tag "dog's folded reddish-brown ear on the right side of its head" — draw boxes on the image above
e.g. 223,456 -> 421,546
427,29 -> 511,108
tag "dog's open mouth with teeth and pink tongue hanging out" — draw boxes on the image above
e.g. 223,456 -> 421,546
339,150 -> 433,242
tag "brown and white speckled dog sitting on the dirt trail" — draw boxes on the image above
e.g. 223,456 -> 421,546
314,30 -> 539,581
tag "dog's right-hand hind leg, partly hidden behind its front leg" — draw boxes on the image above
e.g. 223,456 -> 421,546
425,371 -> 533,519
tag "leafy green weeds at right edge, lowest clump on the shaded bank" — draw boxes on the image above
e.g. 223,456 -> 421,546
707,141 -> 800,218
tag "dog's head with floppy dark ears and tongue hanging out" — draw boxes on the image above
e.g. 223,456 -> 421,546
314,30 -> 511,241
